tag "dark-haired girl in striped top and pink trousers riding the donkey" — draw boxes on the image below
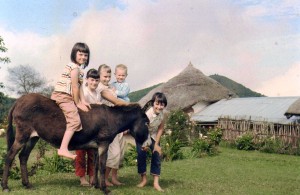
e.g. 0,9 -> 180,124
51,43 -> 90,160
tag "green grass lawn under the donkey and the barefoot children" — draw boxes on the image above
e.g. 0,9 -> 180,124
0,137 -> 300,195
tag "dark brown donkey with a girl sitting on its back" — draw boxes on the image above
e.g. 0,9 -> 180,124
1,94 -> 149,194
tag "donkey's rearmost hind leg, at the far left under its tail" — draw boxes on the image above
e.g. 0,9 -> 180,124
1,140 -> 24,192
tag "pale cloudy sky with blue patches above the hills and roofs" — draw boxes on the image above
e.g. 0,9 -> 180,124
0,0 -> 300,96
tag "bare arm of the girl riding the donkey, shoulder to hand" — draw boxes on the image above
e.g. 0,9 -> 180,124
71,68 -> 89,112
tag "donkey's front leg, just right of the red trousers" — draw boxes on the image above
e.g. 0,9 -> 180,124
98,142 -> 110,194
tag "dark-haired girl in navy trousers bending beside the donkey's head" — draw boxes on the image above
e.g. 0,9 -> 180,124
136,92 -> 167,191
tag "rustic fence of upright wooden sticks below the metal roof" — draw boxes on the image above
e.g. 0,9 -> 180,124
218,118 -> 300,147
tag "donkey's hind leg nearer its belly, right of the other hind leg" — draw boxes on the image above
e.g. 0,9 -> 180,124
19,137 -> 39,188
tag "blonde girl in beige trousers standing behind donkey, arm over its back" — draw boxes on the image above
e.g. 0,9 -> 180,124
98,64 -> 129,186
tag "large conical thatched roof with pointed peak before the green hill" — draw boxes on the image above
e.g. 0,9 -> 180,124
139,63 -> 236,110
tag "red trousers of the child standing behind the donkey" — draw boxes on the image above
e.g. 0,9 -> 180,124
75,149 -> 94,177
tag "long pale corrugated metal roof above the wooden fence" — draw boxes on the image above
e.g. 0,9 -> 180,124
191,97 -> 299,124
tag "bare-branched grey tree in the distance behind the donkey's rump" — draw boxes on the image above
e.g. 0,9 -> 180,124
7,65 -> 47,95
